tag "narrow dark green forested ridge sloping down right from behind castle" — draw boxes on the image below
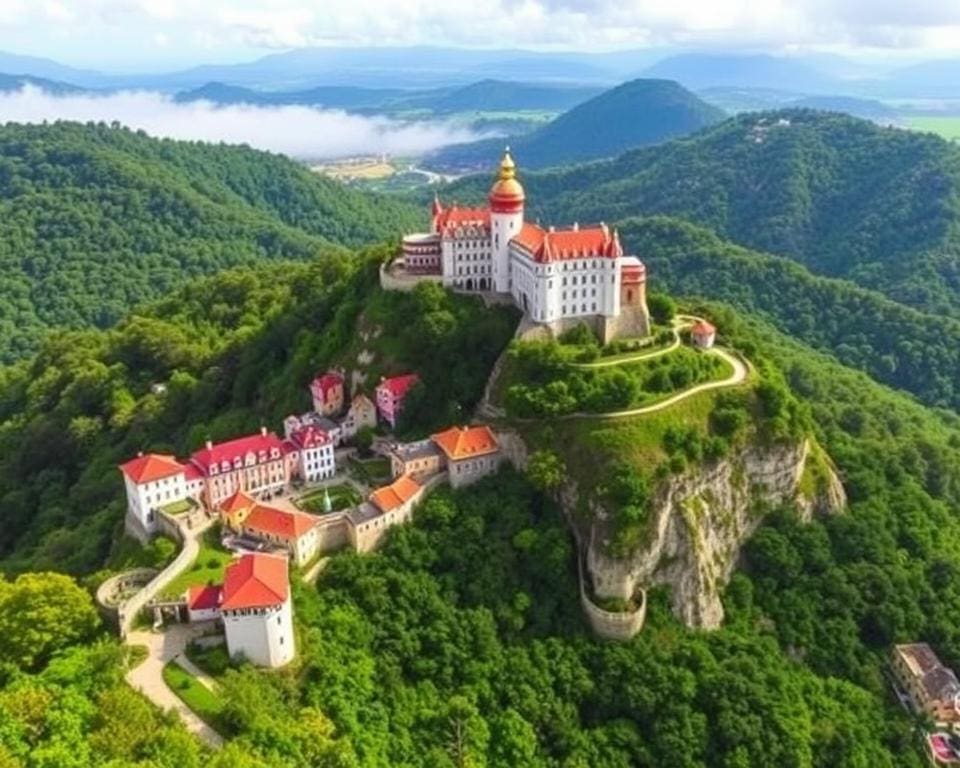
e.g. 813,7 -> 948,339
621,217 -> 960,410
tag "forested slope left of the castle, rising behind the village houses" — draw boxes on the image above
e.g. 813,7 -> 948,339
0,249 -> 516,573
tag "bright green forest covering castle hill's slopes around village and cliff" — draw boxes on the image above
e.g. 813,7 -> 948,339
9,249 -> 960,768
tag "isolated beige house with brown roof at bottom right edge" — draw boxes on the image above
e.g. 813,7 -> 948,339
893,643 -> 960,723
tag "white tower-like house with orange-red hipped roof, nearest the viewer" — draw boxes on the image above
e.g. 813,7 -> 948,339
220,553 -> 295,667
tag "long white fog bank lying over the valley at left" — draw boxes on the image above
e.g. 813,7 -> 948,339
0,87 -> 477,159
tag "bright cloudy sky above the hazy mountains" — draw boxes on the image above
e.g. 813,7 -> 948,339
0,0 -> 960,71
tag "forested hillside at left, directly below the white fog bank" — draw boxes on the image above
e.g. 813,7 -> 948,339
0,123 -> 419,362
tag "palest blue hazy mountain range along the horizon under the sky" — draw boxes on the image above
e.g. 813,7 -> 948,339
0,46 -> 960,99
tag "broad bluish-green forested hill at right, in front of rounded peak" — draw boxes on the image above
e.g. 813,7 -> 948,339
446,110 -> 960,317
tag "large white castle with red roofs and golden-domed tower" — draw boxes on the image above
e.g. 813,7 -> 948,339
392,150 -> 649,343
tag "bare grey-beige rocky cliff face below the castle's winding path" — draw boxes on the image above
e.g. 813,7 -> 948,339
580,441 -> 846,629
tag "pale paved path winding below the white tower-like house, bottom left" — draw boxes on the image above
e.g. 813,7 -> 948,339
126,624 -> 223,749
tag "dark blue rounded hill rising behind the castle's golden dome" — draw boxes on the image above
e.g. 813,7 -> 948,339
427,80 -> 724,170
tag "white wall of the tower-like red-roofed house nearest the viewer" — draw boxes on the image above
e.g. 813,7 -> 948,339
222,597 -> 295,667
